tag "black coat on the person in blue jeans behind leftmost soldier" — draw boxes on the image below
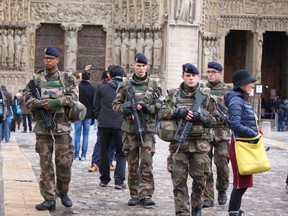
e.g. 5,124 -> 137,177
79,80 -> 96,119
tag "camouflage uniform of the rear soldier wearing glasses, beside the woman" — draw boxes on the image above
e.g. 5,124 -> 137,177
204,82 -> 232,203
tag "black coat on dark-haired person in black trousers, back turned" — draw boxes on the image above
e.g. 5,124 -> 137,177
96,77 -> 122,129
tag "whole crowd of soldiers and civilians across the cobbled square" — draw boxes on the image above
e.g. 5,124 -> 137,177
0,46 -> 288,216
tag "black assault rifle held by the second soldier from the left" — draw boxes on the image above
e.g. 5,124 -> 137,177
125,86 -> 147,146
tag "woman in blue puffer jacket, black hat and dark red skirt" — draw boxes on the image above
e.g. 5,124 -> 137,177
224,70 -> 259,216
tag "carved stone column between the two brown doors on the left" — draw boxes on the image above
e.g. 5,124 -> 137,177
61,23 -> 82,72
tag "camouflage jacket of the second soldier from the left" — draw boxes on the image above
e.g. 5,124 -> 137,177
112,74 -> 162,133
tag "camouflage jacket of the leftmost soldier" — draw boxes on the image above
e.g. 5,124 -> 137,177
25,69 -> 79,135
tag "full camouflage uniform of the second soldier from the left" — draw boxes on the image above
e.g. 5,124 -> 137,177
113,74 -> 162,200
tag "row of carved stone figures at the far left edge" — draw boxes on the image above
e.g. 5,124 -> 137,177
0,28 -> 28,70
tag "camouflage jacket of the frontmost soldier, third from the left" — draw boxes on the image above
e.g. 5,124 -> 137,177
158,83 -> 219,152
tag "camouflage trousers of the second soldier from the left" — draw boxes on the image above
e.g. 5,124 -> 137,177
123,133 -> 155,200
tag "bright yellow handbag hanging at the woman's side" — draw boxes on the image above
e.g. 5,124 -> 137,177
235,134 -> 272,175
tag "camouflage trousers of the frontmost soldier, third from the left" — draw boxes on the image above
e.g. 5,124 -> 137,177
167,152 -> 210,216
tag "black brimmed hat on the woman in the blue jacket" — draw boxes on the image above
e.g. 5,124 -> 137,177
232,69 -> 256,90
